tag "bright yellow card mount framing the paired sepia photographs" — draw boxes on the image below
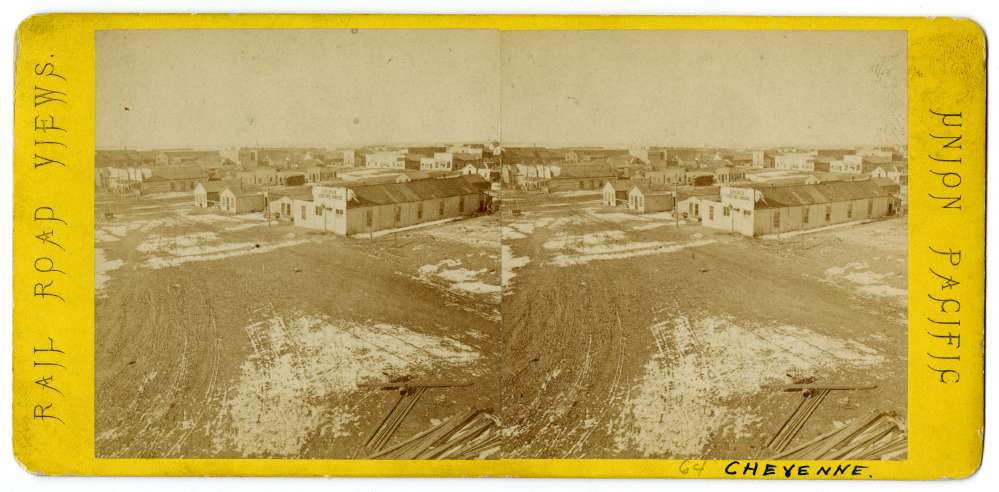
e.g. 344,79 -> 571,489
13,14 -> 986,479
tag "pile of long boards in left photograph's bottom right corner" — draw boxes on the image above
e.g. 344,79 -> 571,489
368,409 -> 502,460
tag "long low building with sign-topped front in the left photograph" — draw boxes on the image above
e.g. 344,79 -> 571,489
291,176 -> 486,236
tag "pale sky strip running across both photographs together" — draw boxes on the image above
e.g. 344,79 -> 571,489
96,29 -> 907,148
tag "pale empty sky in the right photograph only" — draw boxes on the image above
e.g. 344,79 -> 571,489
501,31 -> 908,147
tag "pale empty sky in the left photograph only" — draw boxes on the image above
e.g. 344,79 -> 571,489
96,29 -> 500,148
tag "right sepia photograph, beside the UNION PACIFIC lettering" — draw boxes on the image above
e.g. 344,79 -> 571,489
499,30 -> 908,460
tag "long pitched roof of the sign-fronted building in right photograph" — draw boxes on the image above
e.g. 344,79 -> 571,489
752,179 -> 887,208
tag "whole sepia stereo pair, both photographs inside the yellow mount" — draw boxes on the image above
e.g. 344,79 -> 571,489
94,28 -> 908,460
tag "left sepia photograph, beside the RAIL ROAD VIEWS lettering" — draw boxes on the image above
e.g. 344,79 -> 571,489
94,29 -> 502,459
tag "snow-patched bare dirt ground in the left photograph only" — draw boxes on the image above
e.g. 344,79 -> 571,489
95,194 -> 500,458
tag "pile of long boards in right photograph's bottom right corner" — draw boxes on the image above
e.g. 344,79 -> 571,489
772,413 -> 907,460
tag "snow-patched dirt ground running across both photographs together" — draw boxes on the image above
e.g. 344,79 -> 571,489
95,189 -> 907,458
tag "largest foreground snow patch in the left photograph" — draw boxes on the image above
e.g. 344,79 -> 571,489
213,315 -> 479,457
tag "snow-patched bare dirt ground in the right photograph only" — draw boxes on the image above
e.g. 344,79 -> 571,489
501,193 -> 907,458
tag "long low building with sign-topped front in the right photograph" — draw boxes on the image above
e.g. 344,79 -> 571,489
700,179 -> 897,237
